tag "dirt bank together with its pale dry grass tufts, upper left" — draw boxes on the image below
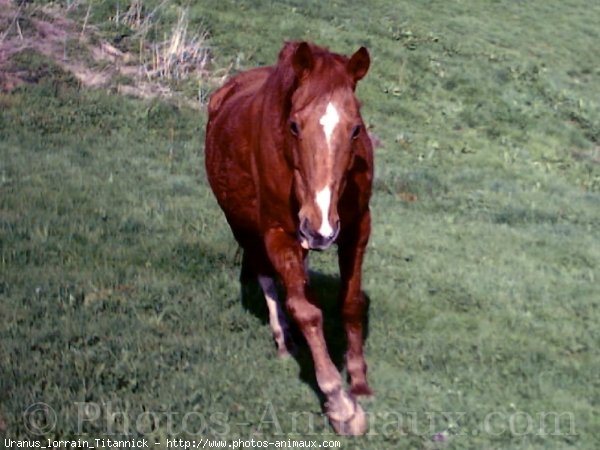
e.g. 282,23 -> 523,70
0,0 -> 229,108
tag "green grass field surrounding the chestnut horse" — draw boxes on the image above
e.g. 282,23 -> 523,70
0,0 -> 600,449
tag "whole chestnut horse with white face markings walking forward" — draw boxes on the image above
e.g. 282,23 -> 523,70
205,42 -> 373,435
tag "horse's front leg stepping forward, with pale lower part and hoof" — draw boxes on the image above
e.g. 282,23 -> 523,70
265,229 -> 367,435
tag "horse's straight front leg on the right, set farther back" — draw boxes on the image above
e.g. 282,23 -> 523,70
338,211 -> 372,395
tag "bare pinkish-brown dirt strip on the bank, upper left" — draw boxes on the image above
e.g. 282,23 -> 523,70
0,0 -> 220,107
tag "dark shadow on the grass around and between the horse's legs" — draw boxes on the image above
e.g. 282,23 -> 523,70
242,271 -> 370,405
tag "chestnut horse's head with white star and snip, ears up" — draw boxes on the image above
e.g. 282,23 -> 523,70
286,42 -> 370,250
